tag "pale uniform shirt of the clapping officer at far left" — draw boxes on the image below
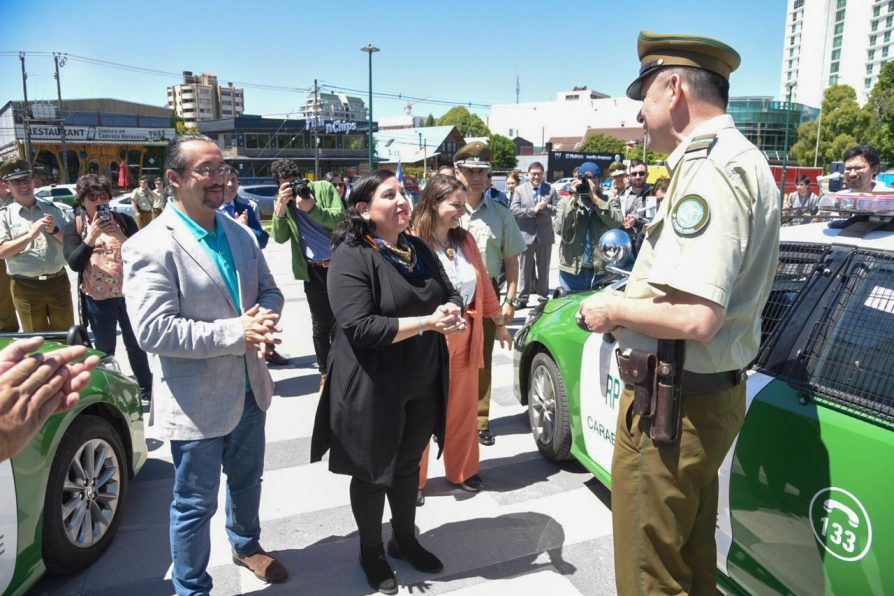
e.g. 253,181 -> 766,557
0,199 -> 65,277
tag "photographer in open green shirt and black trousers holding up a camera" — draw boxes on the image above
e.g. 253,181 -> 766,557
269,159 -> 345,387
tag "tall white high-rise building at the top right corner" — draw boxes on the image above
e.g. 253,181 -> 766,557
779,0 -> 894,107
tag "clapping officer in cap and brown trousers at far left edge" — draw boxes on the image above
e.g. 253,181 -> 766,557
0,159 -> 74,333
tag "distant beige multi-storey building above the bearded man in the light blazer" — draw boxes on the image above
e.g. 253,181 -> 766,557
168,70 -> 245,126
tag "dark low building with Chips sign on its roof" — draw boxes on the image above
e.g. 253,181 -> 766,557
198,114 -> 376,178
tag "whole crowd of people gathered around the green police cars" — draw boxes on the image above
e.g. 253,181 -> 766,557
0,26 -> 892,594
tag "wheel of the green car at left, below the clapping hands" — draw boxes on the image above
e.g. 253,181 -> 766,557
43,415 -> 128,574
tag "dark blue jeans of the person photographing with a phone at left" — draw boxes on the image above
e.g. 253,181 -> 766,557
84,295 -> 152,391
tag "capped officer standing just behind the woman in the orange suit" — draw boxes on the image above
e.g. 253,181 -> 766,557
453,141 -> 527,446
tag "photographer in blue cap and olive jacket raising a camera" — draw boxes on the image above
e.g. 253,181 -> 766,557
553,161 -> 622,292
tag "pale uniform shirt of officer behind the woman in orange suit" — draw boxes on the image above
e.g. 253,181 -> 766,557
462,193 -> 528,278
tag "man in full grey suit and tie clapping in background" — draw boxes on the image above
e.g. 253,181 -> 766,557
509,161 -> 559,308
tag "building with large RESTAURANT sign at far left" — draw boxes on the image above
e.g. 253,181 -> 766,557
0,99 -> 175,186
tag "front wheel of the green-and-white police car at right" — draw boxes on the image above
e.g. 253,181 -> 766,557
528,352 -> 571,461
